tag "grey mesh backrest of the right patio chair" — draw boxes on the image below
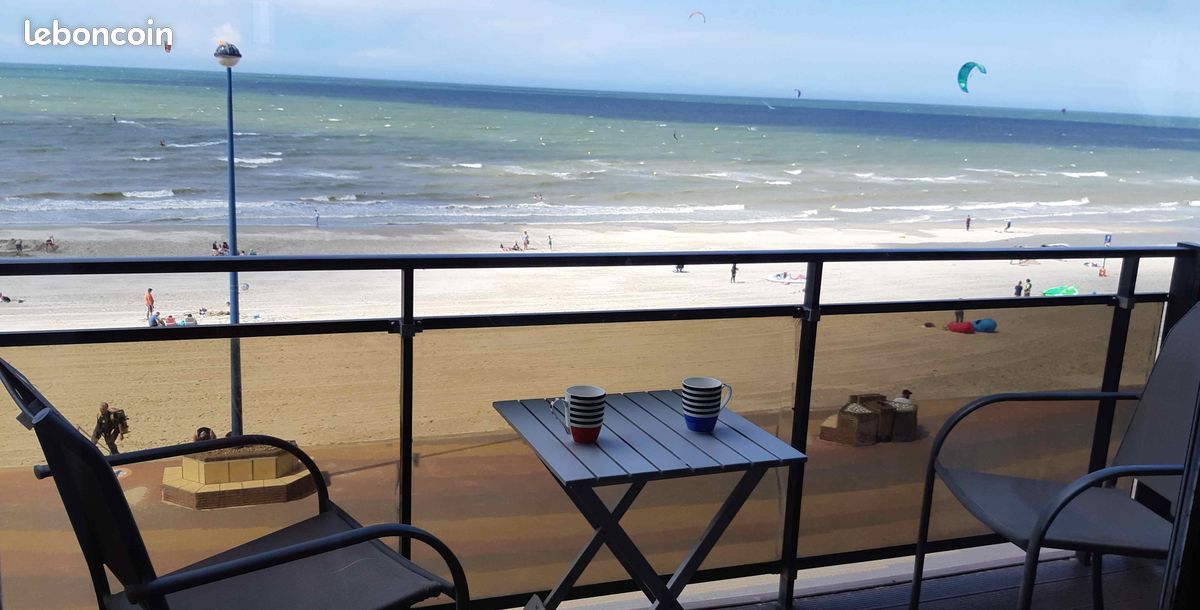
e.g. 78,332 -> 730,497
1112,305 -> 1200,514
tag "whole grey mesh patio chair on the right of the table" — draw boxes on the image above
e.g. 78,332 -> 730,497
908,306 -> 1200,610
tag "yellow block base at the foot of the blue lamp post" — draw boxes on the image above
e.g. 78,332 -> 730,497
162,445 -> 317,510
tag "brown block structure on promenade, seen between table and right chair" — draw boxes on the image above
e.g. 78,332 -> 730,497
820,394 -> 919,447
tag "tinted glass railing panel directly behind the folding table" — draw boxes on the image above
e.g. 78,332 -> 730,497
413,318 -> 797,597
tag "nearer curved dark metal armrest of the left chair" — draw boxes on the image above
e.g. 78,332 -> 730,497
125,524 -> 470,610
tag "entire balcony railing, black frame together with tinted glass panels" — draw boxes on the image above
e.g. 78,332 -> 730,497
0,240 -> 1200,609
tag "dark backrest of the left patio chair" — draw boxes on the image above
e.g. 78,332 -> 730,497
0,359 -> 155,597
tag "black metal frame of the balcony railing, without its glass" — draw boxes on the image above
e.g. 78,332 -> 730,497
0,244 -> 1200,610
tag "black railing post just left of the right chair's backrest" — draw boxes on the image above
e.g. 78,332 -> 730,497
1087,257 -> 1139,472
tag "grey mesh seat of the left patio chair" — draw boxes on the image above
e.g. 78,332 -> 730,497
104,508 -> 454,610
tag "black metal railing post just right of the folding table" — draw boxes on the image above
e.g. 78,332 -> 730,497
779,262 -> 823,610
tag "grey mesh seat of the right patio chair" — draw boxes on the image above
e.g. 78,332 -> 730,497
937,467 -> 1171,557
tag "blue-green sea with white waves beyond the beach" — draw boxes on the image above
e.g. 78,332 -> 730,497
0,64 -> 1200,231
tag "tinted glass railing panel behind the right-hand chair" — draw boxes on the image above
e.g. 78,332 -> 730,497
799,305 -> 1112,556
